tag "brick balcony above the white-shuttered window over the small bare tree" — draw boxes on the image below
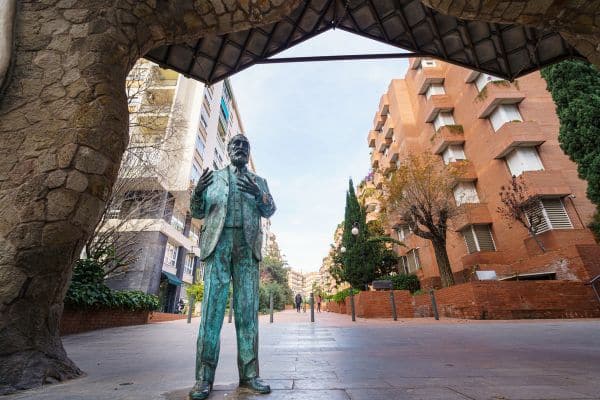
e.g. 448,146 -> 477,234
492,121 -> 545,159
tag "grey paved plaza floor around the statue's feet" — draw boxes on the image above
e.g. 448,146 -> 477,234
6,311 -> 600,400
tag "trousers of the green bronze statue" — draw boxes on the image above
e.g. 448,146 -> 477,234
196,227 -> 259,383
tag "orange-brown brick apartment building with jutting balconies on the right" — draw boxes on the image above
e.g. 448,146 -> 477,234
366,58 -> 600,287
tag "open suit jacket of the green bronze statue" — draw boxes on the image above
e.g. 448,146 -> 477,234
191,165 -> 275,260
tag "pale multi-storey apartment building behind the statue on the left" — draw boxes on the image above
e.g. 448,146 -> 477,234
108,60 -> 270,312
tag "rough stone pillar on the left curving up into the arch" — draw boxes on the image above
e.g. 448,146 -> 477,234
0,0 -> 598,394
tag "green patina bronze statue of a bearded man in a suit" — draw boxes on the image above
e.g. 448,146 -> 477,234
190,135 -> 275,400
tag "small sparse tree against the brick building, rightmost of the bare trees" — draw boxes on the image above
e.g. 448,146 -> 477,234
498,176 -> 546,252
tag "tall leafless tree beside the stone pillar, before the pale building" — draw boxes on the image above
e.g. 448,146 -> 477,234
85,61 -> 187,276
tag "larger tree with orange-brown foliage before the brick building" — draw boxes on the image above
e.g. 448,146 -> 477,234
382,154 -> 463,287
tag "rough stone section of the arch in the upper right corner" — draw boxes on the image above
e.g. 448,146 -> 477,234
421,0 -> 600,67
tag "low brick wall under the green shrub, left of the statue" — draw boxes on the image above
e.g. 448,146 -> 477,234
60,310 -> 150,335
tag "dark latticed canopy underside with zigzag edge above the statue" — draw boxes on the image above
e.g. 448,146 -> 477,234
145,0 -> 581,84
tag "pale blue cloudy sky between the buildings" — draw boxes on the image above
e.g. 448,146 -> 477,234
231,30 -> 408,273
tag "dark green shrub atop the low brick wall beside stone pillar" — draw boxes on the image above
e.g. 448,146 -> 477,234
65,259 -> 159,310
